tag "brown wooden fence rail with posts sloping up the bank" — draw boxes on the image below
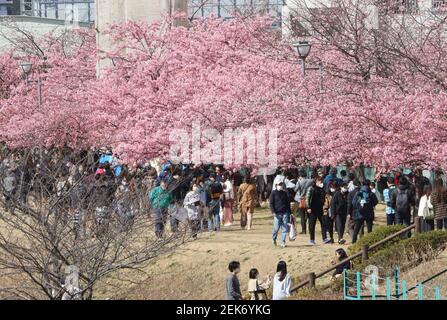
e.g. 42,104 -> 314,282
290,217 -> 421,293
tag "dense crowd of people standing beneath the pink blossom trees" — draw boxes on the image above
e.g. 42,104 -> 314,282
0,149 -> 447,242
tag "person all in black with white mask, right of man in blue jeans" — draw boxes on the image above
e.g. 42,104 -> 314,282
306,176 -> 327,245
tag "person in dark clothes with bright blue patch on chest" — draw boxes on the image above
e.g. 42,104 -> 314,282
352,180 -> 379,244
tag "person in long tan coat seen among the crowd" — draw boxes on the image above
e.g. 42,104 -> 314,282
237,176 -> 258,230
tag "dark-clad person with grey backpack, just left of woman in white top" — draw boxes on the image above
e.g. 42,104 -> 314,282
391,177 -> 416,236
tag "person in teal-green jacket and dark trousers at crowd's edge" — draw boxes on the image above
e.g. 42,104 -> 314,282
149,180 -> 173,238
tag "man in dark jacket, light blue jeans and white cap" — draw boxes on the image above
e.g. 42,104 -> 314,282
270,182 -> 291,248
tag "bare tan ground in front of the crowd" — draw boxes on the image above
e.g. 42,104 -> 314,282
96,205 -> 385,299
